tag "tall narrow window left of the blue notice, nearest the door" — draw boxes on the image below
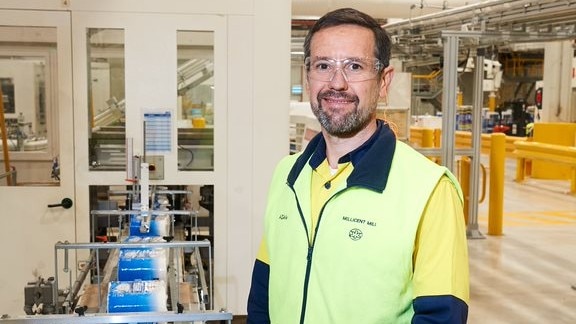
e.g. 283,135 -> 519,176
87,28 -> 126,171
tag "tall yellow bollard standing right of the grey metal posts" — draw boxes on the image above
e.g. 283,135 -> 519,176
488,133 -> 506,235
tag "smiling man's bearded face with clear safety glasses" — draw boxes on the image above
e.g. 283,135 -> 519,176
306,25 -> 391,137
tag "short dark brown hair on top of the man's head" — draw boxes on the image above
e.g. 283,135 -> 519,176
304,8 -> 391,68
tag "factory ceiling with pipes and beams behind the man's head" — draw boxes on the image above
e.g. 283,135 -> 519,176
292,0 -> 576,65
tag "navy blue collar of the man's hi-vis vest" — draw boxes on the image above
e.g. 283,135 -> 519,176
287,120 -> 396,192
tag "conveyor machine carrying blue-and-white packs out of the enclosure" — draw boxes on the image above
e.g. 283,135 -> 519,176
10,141 -> 232,323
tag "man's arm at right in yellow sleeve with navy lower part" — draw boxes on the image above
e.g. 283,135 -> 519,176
412,176 -> 469,324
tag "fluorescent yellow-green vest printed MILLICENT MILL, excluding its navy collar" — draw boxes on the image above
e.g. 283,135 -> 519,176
264,141 -> 458,324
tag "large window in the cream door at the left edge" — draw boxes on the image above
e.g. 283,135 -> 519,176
0,26 -> 59,185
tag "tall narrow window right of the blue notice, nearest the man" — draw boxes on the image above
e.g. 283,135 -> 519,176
176,31 -> 214,171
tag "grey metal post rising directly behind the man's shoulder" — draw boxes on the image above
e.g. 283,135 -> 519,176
440,33 -> 458,171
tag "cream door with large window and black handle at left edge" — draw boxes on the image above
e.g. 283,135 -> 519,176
0,10 -> 76,315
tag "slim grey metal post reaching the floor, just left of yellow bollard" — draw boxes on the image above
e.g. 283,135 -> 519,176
466,49 -> 485,238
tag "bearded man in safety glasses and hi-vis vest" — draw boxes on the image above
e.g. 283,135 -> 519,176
248,9 -> 469,324
